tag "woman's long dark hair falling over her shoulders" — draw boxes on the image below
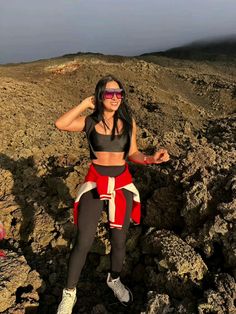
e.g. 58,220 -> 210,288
91,75 -> 133,139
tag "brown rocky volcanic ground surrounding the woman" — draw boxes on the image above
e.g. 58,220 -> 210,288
0,54 -> 236,314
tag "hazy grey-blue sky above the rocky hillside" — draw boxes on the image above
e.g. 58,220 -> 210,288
0,0 -> 236,63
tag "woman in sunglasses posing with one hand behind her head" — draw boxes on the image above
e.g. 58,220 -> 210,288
55,75 -> 169,314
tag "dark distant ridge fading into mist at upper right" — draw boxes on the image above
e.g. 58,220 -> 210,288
141,34 -> 236,61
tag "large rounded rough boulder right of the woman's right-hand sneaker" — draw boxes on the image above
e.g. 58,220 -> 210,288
142,230 -> 207,297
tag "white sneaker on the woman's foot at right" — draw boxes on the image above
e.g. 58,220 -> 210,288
107,273 -> 133,306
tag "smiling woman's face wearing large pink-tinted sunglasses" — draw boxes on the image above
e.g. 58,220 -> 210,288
103,81 -> 122,112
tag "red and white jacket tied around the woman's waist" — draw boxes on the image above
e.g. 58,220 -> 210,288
74,164 -> 141,229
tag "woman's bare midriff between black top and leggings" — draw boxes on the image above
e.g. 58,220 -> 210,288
92,152 -> 125,166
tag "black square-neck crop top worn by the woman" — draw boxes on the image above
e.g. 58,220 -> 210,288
85,116 -> 130,159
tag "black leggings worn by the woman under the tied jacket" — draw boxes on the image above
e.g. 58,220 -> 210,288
66,164 -> 133,288
